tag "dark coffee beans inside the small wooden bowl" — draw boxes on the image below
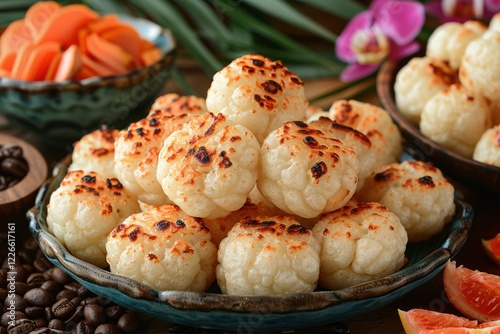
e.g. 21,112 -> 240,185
0,144 -> 28,191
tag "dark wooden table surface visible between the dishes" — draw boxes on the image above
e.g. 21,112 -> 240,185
0,61 -> 500,334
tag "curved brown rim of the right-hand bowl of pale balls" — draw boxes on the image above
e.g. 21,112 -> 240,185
376,56 -> 500,174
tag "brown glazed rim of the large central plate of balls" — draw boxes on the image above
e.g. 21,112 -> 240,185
27,156 -> 473,314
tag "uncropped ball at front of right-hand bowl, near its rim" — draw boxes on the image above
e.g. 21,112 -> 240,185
420,84 -> 491,158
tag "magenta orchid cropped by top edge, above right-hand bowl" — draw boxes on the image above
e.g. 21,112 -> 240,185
425,0 -> 500,22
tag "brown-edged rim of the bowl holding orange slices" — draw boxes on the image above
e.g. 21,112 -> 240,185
0,14 -> 177,92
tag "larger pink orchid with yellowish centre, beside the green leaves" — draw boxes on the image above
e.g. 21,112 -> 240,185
335,0 -> 425,81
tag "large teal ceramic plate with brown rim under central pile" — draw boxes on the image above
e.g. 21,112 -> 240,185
28,158 -> 473,332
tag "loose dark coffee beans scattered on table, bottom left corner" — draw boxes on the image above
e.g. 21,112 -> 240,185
0,237 -> 142,334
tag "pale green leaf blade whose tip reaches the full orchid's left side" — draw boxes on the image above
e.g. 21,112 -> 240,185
243,0 -> 337,42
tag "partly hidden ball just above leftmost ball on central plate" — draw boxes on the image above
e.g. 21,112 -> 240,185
68,128 -> 119,178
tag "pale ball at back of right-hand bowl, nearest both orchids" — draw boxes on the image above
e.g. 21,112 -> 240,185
426,21 -> 487,70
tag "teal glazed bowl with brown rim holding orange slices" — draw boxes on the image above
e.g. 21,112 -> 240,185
0,15 -> 176,146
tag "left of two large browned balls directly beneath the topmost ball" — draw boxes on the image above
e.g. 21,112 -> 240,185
156,113 -> 260,219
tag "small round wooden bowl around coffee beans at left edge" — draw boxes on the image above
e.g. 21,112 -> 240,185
0,133 -> 48,233
